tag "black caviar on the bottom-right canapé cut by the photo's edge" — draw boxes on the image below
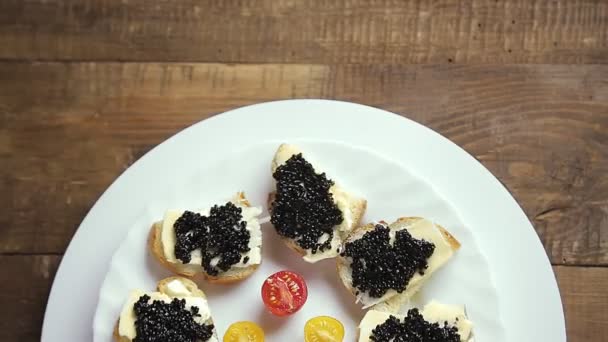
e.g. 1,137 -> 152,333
370,309 -> 460,342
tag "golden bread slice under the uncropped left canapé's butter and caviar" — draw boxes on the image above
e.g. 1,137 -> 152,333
148,192 -> 261,284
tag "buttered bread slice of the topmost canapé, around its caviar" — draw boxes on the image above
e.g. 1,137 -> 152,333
268,144 -> 367,263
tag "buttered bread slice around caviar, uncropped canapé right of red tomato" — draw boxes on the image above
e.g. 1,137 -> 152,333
337,217 -> 460,312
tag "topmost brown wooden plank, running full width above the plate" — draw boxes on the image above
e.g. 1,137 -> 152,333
0,0 -> 608,64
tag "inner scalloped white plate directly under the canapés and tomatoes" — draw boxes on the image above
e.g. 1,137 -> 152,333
93,141 -> 506,342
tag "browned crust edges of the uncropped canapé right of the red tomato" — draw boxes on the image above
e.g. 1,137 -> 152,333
336,217 -> 460,311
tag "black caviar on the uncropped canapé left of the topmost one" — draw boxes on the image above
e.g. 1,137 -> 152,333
173,202 -> 251,276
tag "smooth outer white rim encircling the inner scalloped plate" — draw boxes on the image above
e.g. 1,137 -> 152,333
41,99 -> 566,341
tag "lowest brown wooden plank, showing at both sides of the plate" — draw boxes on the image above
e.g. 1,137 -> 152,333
0,255 -> 608,342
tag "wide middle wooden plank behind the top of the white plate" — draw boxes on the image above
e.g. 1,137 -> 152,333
0,63 -> 608,265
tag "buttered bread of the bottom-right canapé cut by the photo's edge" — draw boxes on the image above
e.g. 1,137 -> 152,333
358,301 -> 473,342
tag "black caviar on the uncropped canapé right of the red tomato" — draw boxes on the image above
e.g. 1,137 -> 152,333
340,224 -> 435,298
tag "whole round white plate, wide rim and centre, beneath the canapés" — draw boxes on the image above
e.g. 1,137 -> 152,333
42,100 -> 566,342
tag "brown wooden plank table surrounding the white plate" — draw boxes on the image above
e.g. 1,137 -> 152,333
0,0 -> 608,342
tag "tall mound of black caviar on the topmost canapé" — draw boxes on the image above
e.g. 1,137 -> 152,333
270,153 -> 343,254
